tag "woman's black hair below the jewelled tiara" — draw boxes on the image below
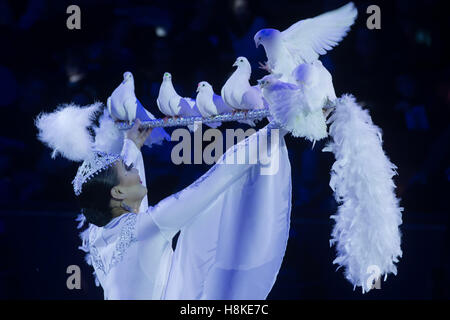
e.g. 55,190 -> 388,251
77,161 -> 120,227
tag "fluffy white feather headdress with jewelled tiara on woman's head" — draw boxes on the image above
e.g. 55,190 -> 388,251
35,102 -> 123,196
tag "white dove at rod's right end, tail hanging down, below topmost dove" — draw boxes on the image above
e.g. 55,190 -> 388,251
258,75 -> 328,143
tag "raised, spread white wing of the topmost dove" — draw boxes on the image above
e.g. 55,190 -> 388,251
281,2 -> 358,64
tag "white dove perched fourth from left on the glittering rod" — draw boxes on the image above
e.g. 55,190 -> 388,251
221,57 -> 265,110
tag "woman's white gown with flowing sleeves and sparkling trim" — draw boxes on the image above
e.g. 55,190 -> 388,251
83,124 -> 291,299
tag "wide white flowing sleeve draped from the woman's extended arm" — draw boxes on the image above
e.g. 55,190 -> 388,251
139,124 -> 291,300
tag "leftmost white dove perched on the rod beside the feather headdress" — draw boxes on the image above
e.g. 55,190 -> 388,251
106,71 -> 137,124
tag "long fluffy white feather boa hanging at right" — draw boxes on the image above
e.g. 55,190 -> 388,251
323,95 -> 403,293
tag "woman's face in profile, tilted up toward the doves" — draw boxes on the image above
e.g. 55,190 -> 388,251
116,160 -> 147,203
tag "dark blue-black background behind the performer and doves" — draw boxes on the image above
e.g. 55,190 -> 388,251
0,0 -> 450,299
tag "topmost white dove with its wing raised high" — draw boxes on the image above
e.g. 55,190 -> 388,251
254,2 -> 358,82
